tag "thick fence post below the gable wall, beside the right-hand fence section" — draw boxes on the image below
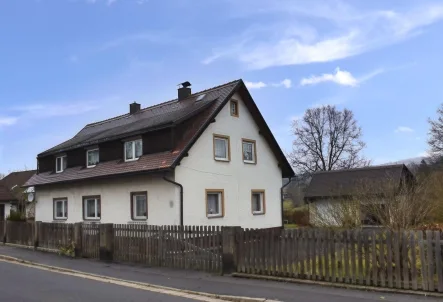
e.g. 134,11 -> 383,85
222,227 -> 242,274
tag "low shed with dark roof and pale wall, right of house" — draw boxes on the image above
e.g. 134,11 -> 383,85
304,164 -> 414,225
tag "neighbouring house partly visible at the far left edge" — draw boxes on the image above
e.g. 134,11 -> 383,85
0,170 -> 36,220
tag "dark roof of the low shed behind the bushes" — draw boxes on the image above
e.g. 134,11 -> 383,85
305,165 -> 412,199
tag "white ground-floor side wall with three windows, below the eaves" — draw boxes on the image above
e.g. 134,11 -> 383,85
35,175 -> 179,225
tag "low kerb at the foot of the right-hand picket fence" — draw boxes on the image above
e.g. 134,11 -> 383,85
231,273 -> 443,298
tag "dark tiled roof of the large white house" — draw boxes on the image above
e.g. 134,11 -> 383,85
26,80 -> 293,186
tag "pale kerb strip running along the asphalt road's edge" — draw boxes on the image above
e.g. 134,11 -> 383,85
0,255 -> 277,302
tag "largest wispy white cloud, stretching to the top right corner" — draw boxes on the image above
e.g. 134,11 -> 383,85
203,0 -> 443,69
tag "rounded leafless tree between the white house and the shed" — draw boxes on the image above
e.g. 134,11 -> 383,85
289,105 -> 370,175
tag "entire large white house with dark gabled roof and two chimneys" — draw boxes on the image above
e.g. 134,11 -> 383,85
27,80 -> 293,228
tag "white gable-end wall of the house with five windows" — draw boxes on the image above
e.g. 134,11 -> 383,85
175,94 -> 282,228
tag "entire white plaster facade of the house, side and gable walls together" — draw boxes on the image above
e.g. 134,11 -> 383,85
35,94 -> 282,228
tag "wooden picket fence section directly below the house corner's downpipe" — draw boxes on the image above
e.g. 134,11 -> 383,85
114,224 -> 222,272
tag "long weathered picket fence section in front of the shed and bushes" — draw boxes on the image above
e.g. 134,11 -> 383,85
237,229 -> 443,292
